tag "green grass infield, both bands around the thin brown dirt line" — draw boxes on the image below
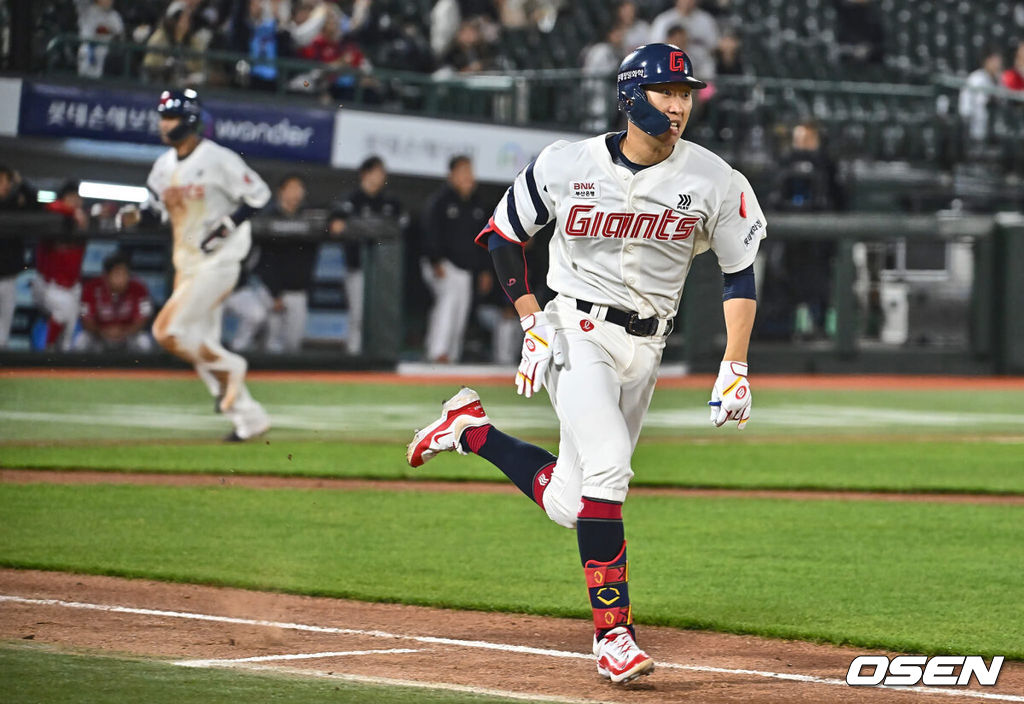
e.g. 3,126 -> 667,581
0,370 -> 1024,679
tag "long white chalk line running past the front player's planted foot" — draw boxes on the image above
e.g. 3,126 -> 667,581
0,595 -> 1024,702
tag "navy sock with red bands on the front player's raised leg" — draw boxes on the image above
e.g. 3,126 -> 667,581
460,426 -> 557,509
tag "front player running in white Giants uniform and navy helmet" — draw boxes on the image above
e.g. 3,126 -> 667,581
407,44 -> 765,683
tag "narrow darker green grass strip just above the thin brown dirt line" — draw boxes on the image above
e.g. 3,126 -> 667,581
0,440 -> 1024,493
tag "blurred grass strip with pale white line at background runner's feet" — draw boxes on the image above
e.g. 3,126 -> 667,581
0,379 -> 1024,441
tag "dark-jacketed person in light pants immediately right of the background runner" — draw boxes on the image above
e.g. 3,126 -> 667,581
255,173 -> 319,353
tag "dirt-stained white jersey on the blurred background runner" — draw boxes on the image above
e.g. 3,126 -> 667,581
146,139 -> 270,273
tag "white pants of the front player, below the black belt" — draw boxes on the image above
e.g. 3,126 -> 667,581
544,296 -> 666,528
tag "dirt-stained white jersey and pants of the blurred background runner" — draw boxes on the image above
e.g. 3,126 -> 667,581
146,139 -> 270,438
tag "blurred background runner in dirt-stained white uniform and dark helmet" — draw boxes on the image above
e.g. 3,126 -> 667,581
122,89 -> 270,441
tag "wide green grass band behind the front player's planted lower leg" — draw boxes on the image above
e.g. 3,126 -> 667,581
0,485 -> 1024,659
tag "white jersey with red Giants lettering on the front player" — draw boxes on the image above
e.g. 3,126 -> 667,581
493,135 -> 766,318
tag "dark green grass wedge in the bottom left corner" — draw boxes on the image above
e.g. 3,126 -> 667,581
0,645 -> 548,704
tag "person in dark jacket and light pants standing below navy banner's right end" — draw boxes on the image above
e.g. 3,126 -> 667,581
328,156 -> 412,354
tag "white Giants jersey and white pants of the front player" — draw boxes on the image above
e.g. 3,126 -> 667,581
485,135 -> 766,527
